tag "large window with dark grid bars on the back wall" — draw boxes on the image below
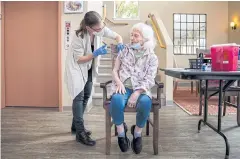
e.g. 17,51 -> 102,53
173,14 -> 207,54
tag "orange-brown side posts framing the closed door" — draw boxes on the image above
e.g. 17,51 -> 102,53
0,1 -> 63,112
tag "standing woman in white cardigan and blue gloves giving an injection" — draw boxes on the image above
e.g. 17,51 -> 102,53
65,11 -> 124,146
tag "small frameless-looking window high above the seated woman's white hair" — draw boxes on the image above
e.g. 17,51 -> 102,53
114,1 -> 139,20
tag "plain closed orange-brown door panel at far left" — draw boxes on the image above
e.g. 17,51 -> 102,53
4,1 -> 59,107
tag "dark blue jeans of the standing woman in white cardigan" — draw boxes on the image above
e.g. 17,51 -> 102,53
72,68 -> 92,132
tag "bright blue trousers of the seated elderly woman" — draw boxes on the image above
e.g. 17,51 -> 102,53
110,88 -> 152,128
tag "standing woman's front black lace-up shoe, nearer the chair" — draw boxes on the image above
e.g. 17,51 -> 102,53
76,131 -> 96,146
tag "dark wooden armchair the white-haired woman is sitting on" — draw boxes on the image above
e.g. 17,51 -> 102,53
100,81 -> 164,155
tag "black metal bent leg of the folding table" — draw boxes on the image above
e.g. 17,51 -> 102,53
198,80 -> 230,159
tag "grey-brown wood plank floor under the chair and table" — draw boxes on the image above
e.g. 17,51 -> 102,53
1,107 -> 240,159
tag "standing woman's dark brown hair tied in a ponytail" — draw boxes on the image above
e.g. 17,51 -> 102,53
76,11 -> 102,38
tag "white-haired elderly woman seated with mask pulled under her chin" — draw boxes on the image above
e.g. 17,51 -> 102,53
110,23 -> 158,154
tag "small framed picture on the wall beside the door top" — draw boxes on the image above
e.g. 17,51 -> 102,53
64,1 -> 83,14
